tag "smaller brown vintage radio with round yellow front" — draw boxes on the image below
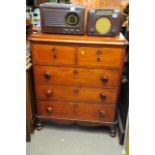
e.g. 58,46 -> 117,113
87,9 -> 121,36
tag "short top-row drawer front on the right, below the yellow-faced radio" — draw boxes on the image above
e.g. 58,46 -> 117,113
78,47 -> 123,68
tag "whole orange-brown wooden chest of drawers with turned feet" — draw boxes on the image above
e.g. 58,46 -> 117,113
30,33 -> 127,136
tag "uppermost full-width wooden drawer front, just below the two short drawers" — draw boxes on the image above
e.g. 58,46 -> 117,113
34,66 -> 119,87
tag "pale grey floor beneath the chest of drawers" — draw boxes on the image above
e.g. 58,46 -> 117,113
26,123 -> 122,155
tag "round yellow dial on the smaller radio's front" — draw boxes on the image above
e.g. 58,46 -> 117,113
95,17 -> 111,34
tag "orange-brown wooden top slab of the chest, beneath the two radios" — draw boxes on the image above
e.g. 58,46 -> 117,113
30,32 -> 128,46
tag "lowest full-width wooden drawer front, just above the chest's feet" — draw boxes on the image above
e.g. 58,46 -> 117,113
38,101 -> 115,122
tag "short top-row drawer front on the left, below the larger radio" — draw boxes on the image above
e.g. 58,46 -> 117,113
33,44 -> 75,65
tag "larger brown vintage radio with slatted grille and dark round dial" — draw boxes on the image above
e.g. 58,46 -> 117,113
40,3 -> 85,34
